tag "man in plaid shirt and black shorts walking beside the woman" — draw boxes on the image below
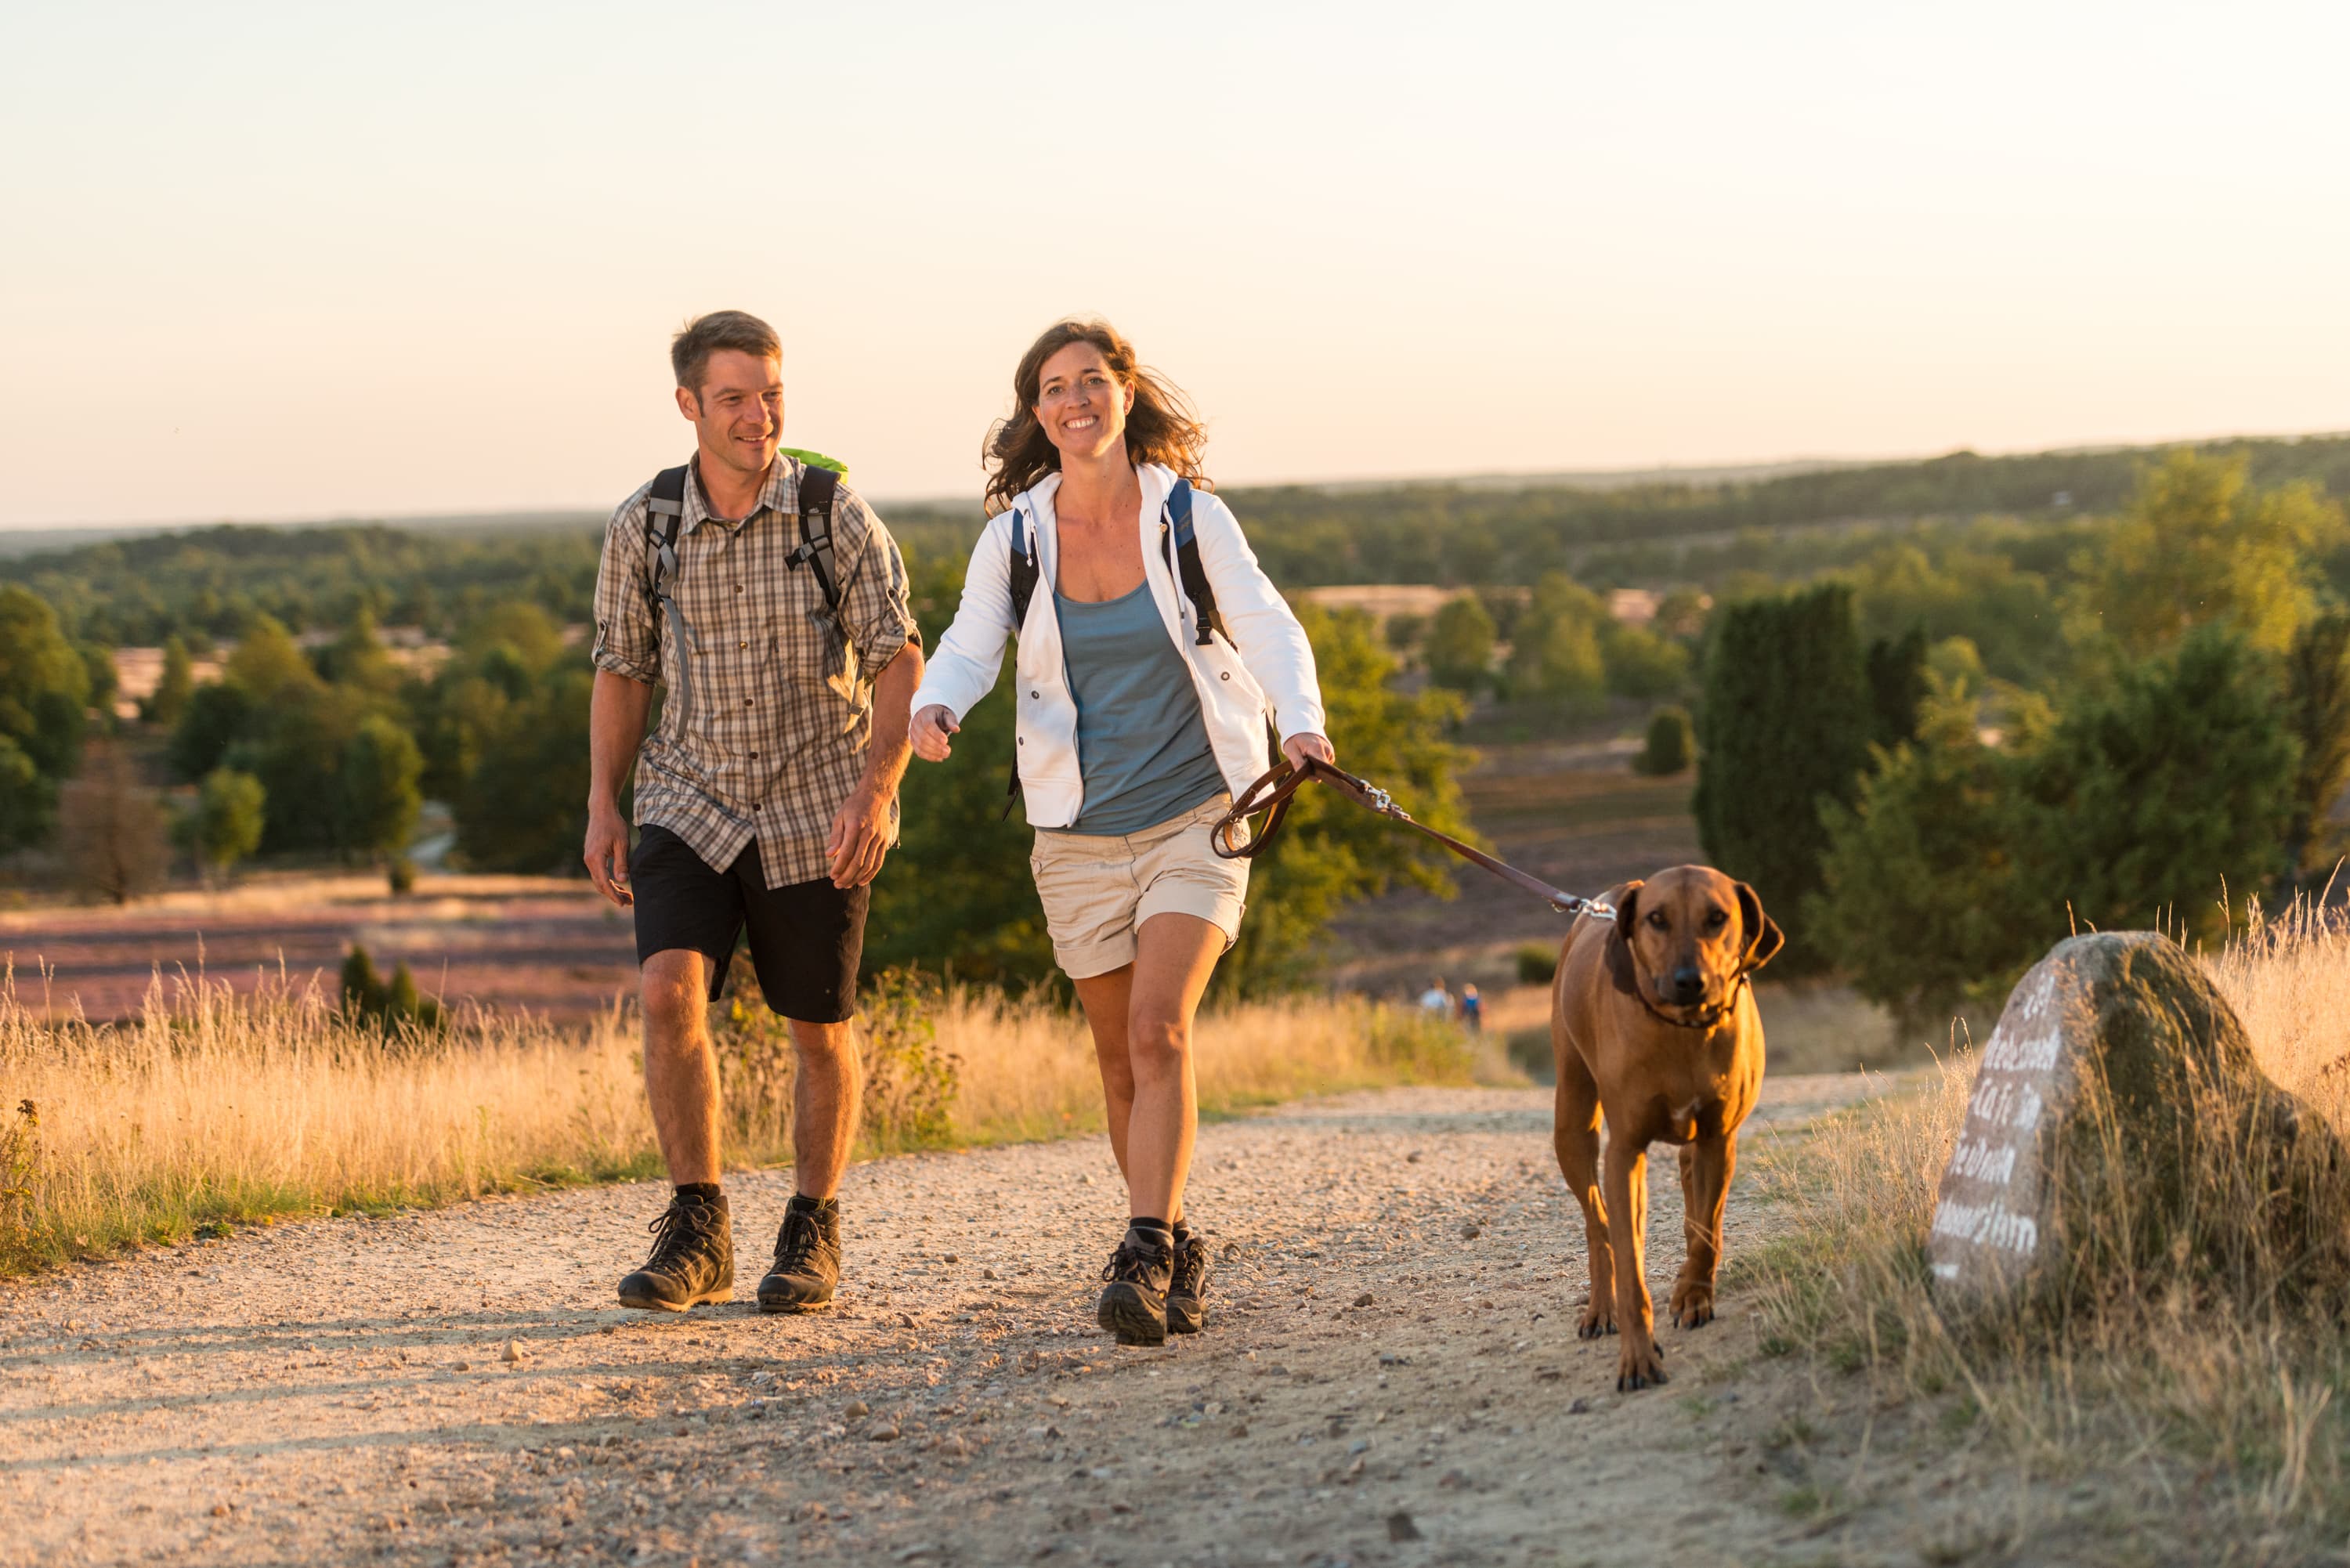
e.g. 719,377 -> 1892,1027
585,310 -> 921,1312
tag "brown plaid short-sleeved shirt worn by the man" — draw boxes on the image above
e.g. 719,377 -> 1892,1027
595,453 -> 921,889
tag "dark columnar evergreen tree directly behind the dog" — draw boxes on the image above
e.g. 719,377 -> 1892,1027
1692,583 -> 1871,969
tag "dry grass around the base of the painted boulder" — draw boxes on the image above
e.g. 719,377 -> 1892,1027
1741,910 -> 2350,1561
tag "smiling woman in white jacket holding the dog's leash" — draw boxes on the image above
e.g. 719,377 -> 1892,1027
914,320 -> 1332,1345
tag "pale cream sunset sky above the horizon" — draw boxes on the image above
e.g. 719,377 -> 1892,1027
0,0 -> 2350,526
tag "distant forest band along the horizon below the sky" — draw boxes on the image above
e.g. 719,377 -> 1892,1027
0,437 -> 2350,646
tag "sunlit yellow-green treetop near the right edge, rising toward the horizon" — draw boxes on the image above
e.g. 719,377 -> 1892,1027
2068,449 -> 2343,658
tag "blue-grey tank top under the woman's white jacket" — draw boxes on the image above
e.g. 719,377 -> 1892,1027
1053,583 -> 1224,835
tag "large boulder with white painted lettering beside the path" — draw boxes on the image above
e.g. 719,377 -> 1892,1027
1927,931 -> 2345,1307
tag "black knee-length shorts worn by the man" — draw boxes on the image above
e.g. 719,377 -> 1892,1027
627,826 -> 872,1023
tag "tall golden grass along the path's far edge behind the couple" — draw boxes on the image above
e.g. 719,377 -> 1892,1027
0,976 -> 1471,1274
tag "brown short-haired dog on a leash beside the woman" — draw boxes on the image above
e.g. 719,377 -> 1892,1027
1551,865 -> 1786,1389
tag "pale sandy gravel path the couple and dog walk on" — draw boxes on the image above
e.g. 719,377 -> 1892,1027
0,1077 -> 1915,1568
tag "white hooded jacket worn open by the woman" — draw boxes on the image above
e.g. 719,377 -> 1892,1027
914,463 -> 1325,828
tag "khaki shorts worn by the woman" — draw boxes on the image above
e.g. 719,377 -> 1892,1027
1029,793 -> 1248,981
